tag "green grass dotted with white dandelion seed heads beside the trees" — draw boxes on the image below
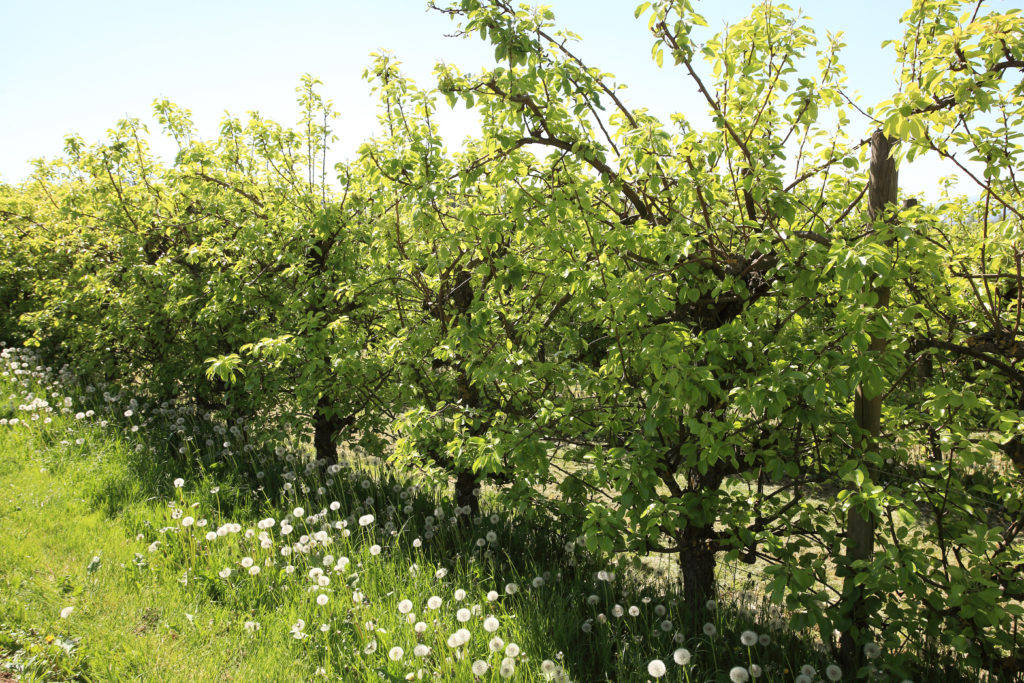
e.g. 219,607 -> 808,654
0,357 -> 950,682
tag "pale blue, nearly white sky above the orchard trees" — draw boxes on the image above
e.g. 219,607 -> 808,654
0,0 -> 1008,196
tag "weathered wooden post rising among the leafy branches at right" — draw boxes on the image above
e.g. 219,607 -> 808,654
840,130 -> 897,675
